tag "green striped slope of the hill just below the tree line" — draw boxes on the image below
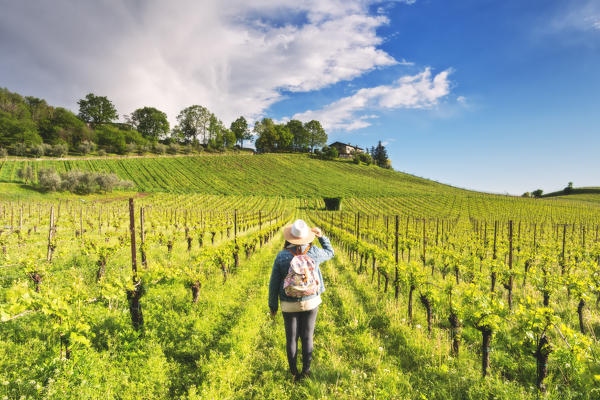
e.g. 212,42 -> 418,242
0,154 -> 458,197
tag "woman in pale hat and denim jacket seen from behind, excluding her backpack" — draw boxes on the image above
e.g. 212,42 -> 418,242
269,219 -> 333,379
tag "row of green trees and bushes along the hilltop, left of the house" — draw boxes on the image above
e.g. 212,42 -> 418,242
0,88 -> 327,157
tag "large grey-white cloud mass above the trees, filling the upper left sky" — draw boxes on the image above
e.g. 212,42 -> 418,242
0,0 -> 404,126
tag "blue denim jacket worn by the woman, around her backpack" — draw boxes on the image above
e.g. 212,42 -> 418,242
269,236 -> 334,312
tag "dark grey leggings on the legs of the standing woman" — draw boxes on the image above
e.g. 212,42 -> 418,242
282,306 -> 319,375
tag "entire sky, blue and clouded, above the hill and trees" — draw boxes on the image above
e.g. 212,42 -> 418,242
0,0 -> 600,194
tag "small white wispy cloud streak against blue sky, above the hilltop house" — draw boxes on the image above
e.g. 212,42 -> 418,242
293,68 -> 451,131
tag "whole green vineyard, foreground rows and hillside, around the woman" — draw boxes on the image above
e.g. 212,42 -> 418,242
0,155 -> 600,399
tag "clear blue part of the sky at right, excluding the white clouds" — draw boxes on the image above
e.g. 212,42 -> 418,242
270,0 -> 600,194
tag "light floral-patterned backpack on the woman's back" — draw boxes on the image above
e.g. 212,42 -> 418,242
283,246 -> 319,297
